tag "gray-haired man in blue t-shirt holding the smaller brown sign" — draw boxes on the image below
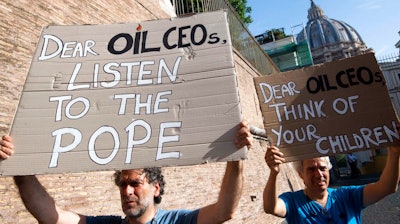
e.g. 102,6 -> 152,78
263,136 -> 400,224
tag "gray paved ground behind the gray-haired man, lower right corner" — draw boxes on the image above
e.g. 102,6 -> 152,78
331,175 -> 400,224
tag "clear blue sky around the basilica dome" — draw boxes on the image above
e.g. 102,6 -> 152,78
247,0 -> 400,58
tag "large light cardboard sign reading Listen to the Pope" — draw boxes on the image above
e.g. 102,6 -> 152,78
0,11 -> 246,175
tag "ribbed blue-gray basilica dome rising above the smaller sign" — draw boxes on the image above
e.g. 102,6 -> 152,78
297,0 -> 371,64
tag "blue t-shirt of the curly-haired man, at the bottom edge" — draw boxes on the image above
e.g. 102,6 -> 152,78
86,209 -> 199,224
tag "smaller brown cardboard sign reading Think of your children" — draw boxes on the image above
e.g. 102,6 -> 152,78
255,54 -> 399,161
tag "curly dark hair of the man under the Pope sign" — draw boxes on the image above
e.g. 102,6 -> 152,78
114,167 -> 165,204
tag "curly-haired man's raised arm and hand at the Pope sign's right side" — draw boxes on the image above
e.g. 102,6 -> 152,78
197,122 -> 253,224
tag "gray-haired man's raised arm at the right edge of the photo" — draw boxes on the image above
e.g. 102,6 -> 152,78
363,145 -> 400,207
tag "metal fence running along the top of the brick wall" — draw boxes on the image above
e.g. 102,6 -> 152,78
171,0 -> 279,75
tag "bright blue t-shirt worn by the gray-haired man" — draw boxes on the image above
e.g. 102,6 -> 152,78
279,186 -> 364,224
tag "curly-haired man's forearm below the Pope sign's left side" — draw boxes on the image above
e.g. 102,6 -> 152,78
14,176 -> 58,223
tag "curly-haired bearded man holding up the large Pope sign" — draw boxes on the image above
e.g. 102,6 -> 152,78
0,122 -> 252,224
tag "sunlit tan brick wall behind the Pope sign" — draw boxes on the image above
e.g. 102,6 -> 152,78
0,0 -> 300,224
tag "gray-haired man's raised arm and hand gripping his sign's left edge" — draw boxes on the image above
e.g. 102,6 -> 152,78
263,146 -> 286,217
